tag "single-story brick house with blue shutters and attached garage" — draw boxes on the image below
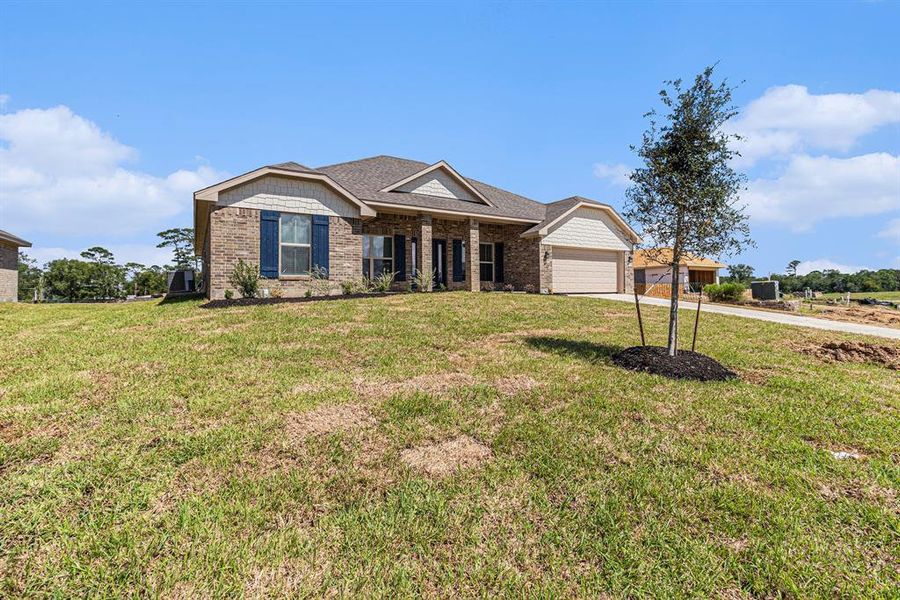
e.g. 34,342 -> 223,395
194,156 -> 639,298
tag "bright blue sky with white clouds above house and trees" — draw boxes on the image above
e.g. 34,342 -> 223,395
0,2 -> 900,273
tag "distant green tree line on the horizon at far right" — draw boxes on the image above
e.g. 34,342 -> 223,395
721,260 -> 900,293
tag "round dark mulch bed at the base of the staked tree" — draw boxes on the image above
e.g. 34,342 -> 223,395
612,346 -> 738,381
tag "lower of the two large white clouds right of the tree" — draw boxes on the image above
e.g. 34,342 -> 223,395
743,152 -> 900,231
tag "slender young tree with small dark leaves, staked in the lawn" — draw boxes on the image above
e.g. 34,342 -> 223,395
625,67 -> 752,356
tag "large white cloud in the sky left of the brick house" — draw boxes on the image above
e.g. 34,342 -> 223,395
0,106 -> 225,238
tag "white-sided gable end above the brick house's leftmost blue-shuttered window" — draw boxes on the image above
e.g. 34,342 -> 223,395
218,175 -> 359,218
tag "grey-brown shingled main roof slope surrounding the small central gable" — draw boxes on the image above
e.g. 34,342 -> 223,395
316,156 -> 547,221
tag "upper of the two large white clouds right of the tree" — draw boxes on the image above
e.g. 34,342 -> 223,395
729,85 -> 900,166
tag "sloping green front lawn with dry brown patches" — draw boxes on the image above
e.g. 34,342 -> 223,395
0,293 -> 900,598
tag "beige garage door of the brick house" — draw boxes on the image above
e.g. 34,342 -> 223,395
553,246 -> 619,294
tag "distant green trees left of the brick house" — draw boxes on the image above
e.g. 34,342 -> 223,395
19,228 -> 198,302
